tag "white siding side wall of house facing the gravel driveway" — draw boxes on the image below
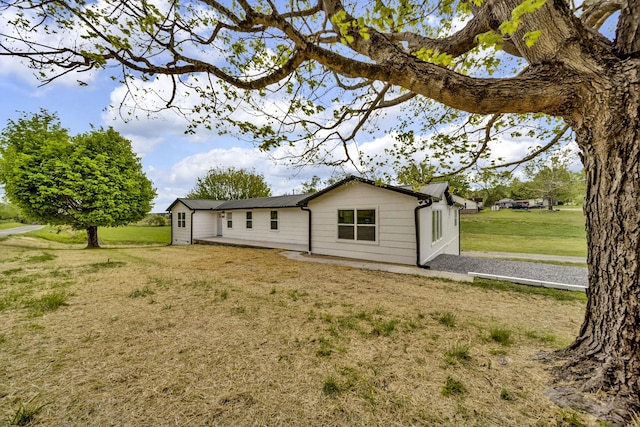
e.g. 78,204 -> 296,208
419,200 -> 460,264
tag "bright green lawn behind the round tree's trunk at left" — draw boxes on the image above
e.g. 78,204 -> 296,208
26,225 -> 171,245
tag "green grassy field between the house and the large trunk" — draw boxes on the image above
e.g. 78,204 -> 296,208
460,209 -> 587,257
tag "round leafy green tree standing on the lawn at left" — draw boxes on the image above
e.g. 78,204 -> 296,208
0,111 -> 156,248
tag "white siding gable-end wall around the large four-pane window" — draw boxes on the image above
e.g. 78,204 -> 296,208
309,182 -> 417,265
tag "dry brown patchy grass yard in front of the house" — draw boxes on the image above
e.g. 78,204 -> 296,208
0,238 -> 592,426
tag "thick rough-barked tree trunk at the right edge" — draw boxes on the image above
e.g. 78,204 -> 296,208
552,61 -> 640,423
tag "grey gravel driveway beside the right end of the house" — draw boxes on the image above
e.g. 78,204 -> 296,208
429,255 -> 587,287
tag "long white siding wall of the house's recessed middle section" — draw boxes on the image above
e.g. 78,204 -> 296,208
222,208 -> 309,245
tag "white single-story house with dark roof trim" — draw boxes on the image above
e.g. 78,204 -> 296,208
167,176 -> 463,266
